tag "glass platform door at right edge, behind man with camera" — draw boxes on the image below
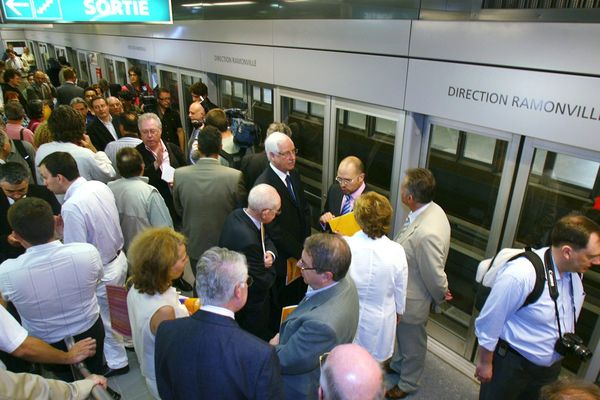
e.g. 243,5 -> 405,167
502,138 -> 600,380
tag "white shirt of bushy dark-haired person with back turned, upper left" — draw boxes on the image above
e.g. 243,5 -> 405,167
35,142 -> 116,185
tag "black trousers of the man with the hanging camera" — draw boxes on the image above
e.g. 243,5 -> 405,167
479,340 -> 561,400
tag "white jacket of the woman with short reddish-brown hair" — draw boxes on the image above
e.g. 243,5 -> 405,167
345,231 -> 408,362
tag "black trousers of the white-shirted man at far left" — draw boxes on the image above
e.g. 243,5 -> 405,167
44,316 -> 104,382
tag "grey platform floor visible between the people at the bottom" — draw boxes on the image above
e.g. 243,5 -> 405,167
108,346 -> 479,400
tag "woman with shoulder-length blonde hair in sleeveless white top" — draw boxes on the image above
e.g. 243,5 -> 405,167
127,228 -> 189,399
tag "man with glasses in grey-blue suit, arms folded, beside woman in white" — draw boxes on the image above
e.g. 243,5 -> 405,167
269,233 -> 358,400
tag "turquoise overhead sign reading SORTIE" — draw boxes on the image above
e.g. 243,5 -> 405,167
1,0 -> 173,23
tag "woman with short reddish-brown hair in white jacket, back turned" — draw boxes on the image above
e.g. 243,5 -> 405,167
346,192 -> 408,362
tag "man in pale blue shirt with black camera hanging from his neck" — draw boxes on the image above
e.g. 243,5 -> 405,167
475,215 -> 600,400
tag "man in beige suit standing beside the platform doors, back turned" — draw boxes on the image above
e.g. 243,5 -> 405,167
385,168 -> 452,399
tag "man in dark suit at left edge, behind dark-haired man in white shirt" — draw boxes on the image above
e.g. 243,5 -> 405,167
0,162 -> 60,262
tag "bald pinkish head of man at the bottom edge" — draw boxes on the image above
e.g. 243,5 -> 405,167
319,344 -> 383,400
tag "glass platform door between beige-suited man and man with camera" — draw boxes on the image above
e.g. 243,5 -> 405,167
426,118 -> 519,359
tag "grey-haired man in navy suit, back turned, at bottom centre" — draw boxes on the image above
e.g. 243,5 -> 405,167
155,247 -> 283,400
